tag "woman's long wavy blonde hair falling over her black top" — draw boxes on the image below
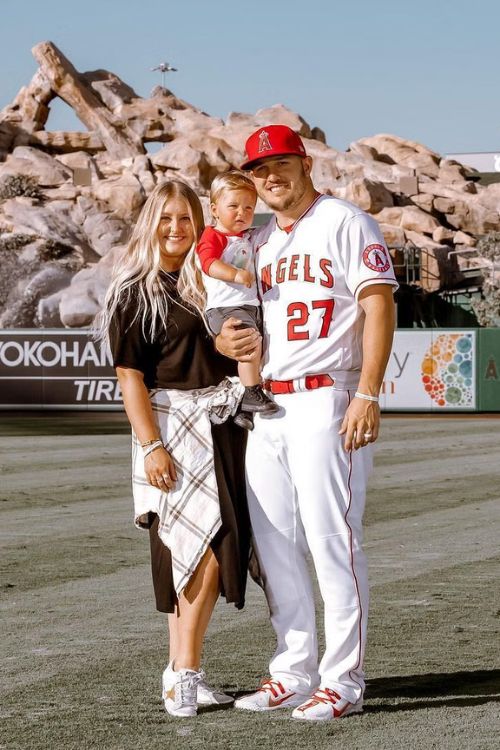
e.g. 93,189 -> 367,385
94,180 -> 205,342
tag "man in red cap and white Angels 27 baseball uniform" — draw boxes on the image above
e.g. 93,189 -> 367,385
217,125 -> 397,720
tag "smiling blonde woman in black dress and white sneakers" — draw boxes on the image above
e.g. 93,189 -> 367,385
98,181 -> 254,716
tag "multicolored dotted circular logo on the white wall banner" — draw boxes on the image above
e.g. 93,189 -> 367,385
422,333 -> 474,407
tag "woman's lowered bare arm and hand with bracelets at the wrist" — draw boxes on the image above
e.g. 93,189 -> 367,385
116,367 -> 177,490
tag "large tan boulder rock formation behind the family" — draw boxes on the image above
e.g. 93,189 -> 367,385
0,42 -> 500,327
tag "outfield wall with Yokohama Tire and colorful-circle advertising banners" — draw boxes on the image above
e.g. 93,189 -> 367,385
0,328 -> 500,413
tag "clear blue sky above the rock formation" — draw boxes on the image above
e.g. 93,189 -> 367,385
0,0 -> 500,153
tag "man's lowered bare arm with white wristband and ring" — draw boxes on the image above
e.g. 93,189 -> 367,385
339,284 -> 395,450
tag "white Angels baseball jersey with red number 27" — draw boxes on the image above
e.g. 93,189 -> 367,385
252,195 -> 397,388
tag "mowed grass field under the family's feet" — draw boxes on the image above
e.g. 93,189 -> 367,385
0,415 -> 500,750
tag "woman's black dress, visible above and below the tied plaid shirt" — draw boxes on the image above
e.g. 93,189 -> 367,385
110,273 -> 250,612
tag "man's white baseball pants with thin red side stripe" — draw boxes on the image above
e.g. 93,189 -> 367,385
246,387 -> 373,703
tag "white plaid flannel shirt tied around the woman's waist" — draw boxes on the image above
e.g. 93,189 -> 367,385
132,378 -> 244,595
